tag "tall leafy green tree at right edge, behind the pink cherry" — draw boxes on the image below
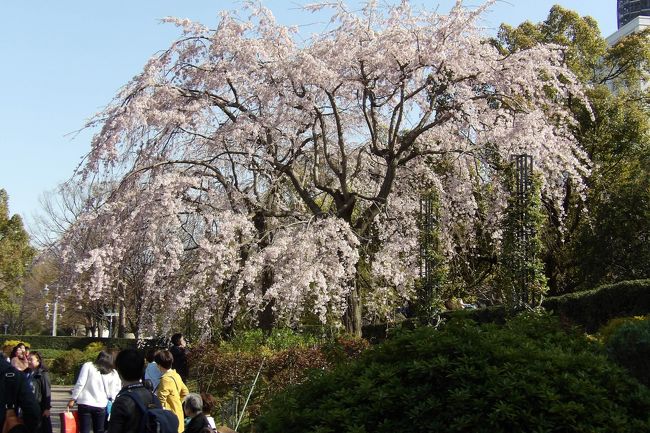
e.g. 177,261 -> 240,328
496,6 -> 650,293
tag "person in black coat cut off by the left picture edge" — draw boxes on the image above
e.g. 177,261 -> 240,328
0,358 -> 41,433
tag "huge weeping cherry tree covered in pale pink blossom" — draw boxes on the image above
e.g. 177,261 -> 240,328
64,2 -> 586,333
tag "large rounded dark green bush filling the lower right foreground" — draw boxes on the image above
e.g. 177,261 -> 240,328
255,315 -> 650,433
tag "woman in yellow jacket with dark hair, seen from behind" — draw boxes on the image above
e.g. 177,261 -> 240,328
154,350 -> 190,433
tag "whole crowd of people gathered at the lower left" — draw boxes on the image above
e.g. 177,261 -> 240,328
0,334 -> 217,433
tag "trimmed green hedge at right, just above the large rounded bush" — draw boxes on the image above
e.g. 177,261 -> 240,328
542,279 -> 650,332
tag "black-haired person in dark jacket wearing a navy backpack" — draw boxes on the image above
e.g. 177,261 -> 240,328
108,349 -> 178,433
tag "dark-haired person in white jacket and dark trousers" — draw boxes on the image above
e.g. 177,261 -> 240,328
68,351 -> 122,433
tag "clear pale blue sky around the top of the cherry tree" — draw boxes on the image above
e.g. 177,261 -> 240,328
0,0 -> 616,233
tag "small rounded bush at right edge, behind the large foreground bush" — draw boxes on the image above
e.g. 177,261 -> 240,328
605,319 -> 650,386
